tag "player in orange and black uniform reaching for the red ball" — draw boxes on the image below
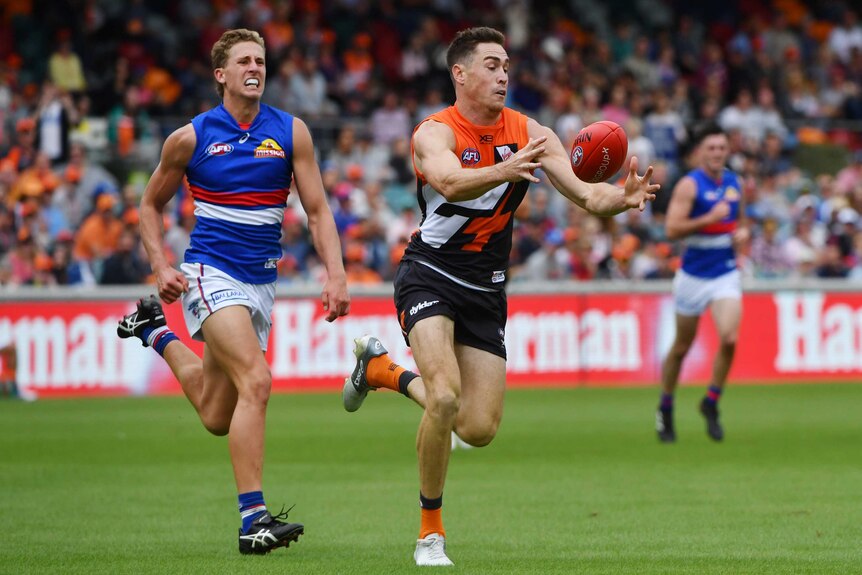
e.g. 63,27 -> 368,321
343,28 -> 659,565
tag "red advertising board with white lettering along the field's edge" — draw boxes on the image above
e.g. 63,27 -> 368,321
0,291 -> 862,396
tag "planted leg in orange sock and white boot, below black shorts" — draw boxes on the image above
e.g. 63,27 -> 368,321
410,315 -> 461,565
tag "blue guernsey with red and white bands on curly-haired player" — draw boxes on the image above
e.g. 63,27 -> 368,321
184,104 -> 293,284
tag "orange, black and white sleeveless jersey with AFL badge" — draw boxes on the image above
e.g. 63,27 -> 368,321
404,106 -> 529,291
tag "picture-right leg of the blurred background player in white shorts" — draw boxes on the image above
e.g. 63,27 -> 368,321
700,297 -> 742,441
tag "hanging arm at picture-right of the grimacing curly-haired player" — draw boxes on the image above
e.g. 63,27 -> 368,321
293,118 -> 350,321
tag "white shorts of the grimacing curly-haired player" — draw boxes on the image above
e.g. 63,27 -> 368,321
180,264 -> 275,351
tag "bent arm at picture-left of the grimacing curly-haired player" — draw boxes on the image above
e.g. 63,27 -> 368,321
140,124 -> 197,303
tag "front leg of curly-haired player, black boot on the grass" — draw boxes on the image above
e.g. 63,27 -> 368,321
202,305 -> 304,554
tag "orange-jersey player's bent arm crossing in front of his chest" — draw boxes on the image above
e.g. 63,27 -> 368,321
413,120 -> 545,202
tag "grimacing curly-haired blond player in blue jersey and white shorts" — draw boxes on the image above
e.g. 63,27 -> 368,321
117,29 -> 350,554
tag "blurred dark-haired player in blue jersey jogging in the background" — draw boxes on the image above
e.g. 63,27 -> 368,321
656,124 -> 747,443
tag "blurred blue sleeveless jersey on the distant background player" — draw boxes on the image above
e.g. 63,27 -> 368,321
682,169 -> 742,278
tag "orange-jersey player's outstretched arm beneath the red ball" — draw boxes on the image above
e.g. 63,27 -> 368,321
527,119 -> 661,216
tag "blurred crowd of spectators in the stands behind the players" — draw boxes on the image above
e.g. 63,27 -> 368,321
0,0 -> 862,286
